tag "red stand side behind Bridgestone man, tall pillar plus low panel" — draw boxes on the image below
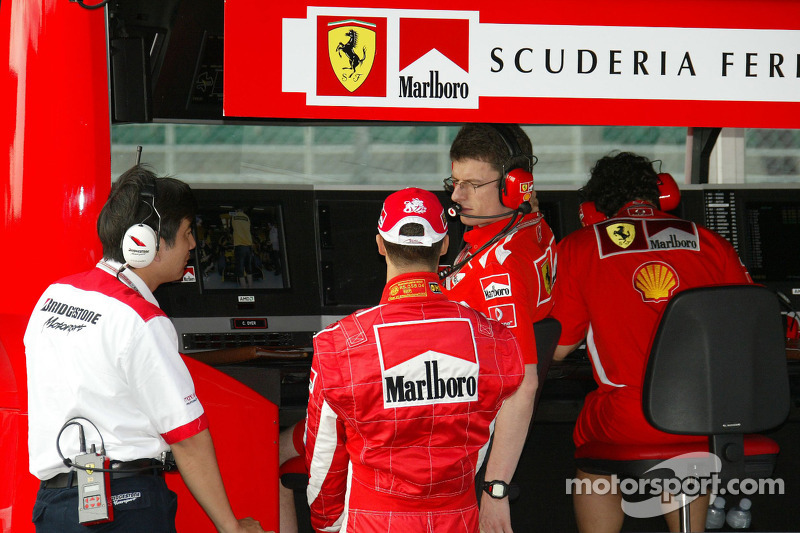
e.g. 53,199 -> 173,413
0,0 -> 278,533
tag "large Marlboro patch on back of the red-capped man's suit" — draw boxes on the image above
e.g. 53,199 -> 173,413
375,318 -> 480,409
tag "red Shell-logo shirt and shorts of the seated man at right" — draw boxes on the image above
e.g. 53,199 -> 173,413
552,203 -> 751,446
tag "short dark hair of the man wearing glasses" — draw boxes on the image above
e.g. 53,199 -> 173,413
450,124 -> 533,173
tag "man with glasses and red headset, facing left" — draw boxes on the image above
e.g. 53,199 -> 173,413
443,124 -> 555,533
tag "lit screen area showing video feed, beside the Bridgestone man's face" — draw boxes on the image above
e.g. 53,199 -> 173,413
195,202 -> 290,290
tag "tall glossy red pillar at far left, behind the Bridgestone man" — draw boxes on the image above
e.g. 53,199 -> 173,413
0,0 -> 111,533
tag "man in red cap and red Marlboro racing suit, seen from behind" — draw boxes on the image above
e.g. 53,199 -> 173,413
305,188 -> 524,533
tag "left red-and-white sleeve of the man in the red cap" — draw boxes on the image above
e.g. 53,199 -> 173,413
305,332 -> 350,531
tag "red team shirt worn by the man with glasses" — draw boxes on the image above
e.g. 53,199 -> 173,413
444,213 -> 555,364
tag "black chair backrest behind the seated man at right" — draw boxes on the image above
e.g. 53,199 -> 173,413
642,285 -> 790,435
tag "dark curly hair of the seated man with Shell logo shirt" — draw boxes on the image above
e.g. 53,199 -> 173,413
581,152 -> 659,217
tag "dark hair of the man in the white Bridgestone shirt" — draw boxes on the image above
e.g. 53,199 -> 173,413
97,165 -> 197,263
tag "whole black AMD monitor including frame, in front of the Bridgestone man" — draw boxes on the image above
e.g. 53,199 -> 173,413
156,187 -> 320,320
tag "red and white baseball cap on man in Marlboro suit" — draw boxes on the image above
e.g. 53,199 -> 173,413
378,187 -> 447,246
